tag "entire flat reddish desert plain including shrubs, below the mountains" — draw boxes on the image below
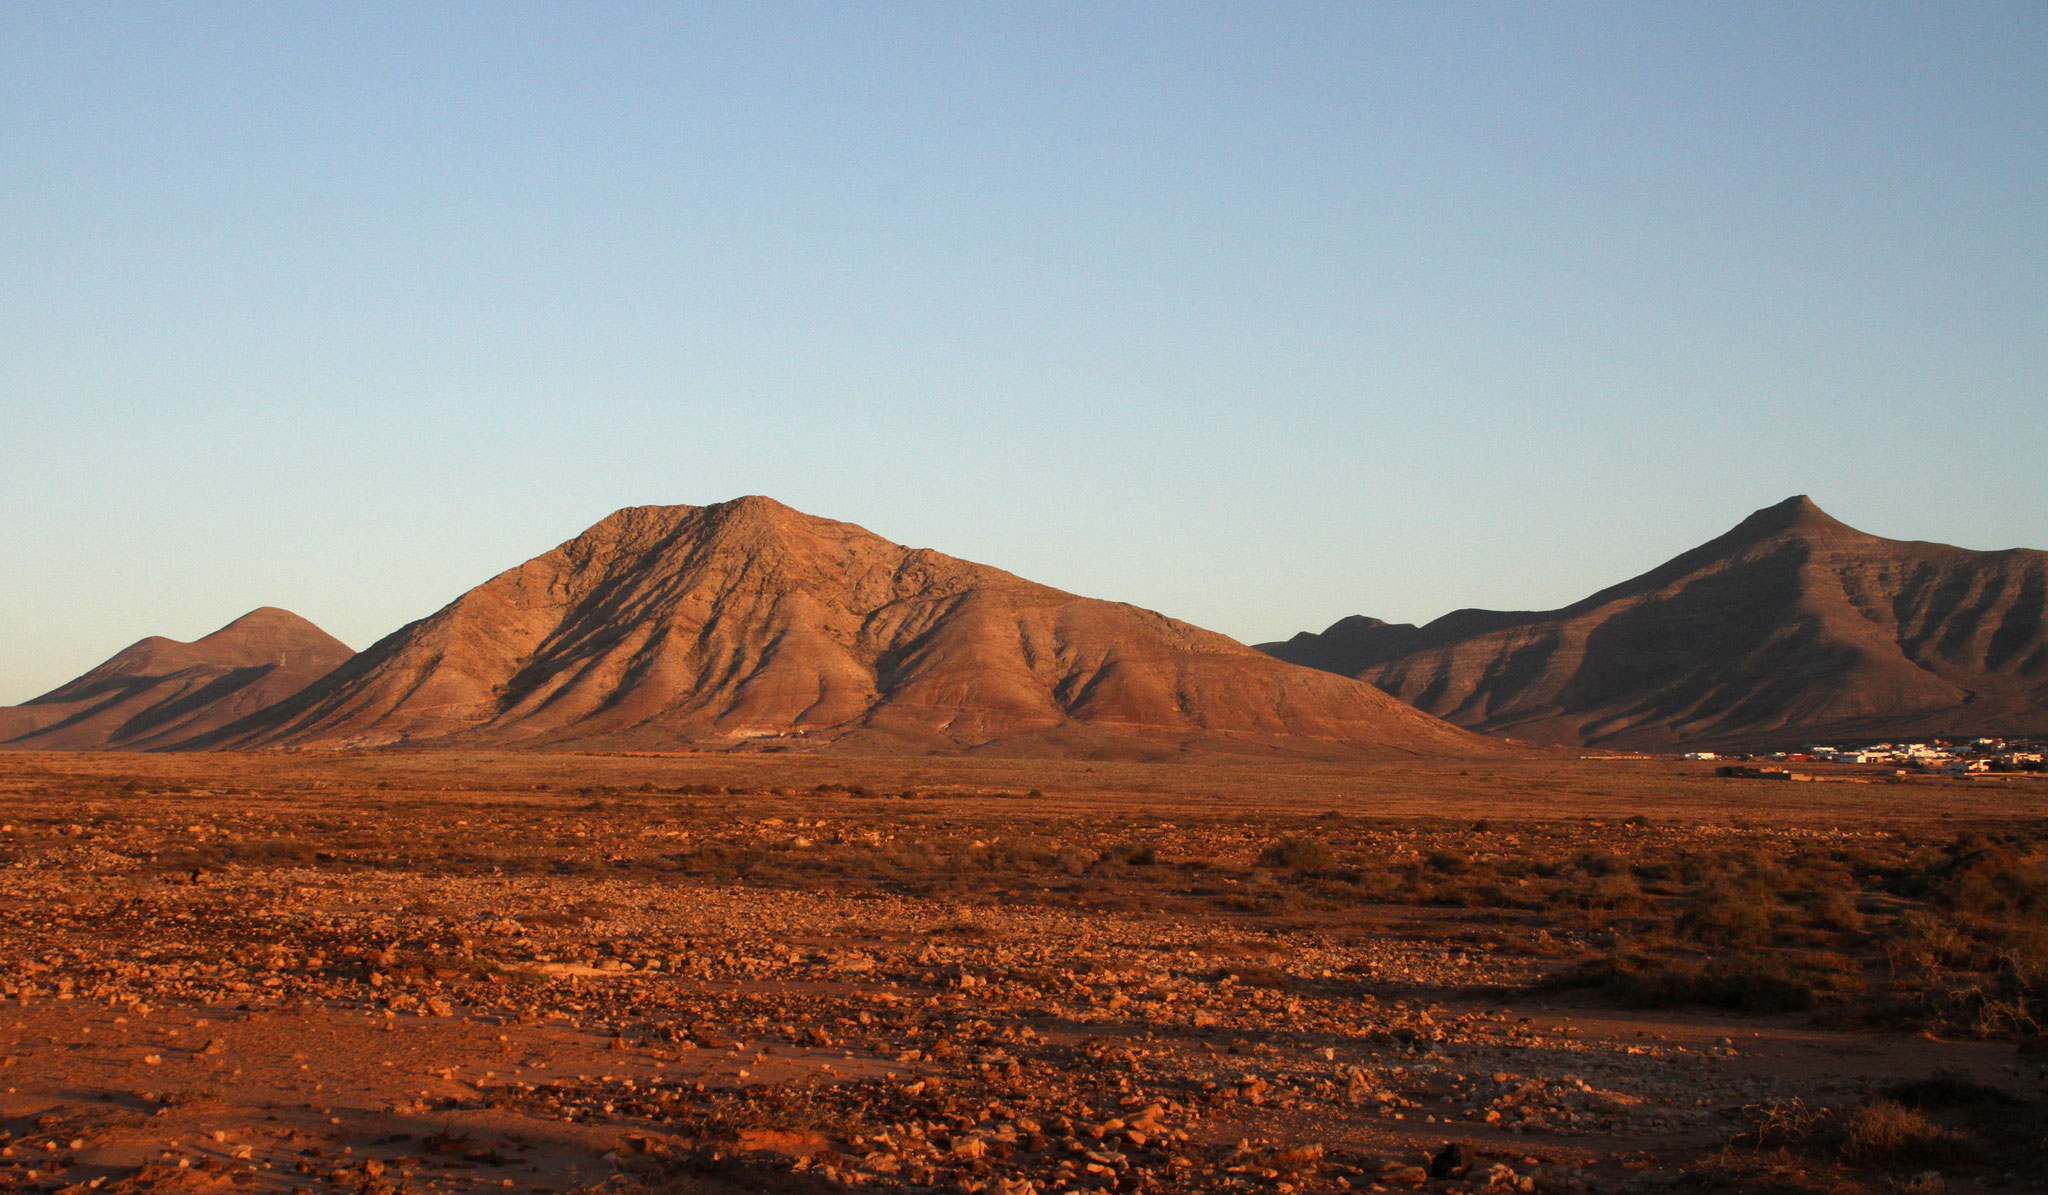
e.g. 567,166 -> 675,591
0,752 -> 2048,1193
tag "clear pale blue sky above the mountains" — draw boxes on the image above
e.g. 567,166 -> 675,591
0,0 -> 2048,701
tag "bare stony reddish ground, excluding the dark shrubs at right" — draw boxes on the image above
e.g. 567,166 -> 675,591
0,756 -> 2048,1193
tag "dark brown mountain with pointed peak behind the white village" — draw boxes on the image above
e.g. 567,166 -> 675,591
1262,496 -> 2048,748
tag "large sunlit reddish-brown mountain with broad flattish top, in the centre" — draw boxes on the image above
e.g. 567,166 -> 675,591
190,498 -> 1499,758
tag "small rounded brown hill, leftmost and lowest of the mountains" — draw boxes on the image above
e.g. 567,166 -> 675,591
0,607 -> 354,750
